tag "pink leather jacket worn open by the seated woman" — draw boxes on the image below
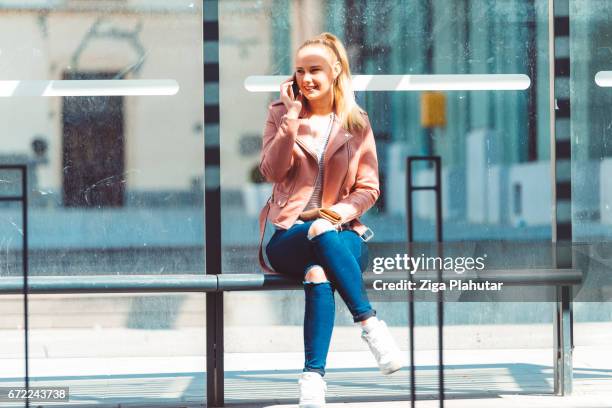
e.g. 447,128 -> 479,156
259,100 -> 380,272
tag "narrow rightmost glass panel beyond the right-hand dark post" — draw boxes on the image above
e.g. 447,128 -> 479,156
572,0 -> 612,395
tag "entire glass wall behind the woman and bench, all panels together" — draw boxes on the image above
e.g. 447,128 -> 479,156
0,0 -> 612,406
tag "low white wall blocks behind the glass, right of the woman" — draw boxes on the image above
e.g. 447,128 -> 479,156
392,130 -> 556,226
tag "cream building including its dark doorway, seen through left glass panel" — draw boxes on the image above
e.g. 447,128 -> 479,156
0,1 -> 204,208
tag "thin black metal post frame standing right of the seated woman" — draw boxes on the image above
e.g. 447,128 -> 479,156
406,156 -> 444,408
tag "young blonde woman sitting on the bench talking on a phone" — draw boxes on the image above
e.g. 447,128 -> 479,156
259,33 -> 401,407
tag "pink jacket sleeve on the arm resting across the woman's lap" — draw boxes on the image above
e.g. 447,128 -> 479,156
330,121 -> 380,224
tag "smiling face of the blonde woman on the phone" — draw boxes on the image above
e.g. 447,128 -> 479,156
295,45 -> 340,101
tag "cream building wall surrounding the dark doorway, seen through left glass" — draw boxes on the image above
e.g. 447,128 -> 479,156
0,9 -> 204,190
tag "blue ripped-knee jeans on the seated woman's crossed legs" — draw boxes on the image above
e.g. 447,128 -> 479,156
266,221 -> 376,375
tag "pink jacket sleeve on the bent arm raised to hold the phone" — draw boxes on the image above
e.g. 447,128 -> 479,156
259,107 -> 299,183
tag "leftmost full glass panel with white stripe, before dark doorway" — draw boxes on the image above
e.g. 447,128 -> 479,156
0,0 -> 206,406
